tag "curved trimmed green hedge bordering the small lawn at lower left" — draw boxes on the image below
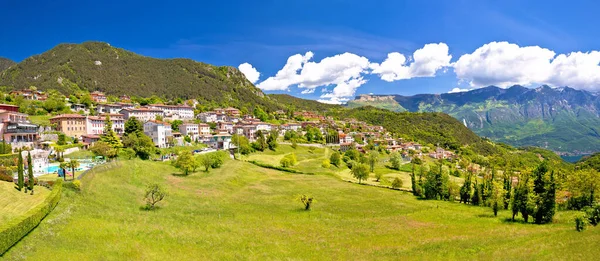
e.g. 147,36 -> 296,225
0,179 -> 63,256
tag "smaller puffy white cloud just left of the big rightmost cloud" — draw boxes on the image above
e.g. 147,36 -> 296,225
371,43 -> 452,82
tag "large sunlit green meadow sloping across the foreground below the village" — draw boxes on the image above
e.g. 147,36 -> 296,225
4,155 -> 600,260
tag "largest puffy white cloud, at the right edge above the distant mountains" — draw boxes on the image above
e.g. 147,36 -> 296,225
453,42 -> 600,90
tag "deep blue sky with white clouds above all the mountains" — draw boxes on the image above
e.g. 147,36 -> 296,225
0,0 -> 600,101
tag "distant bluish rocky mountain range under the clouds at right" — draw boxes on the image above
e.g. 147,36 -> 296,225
347,85 -> 600,154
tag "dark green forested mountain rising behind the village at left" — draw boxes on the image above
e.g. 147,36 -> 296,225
0,42 -> 281,110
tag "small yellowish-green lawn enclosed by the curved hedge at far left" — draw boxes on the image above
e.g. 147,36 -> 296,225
0,181 -> 50,221
